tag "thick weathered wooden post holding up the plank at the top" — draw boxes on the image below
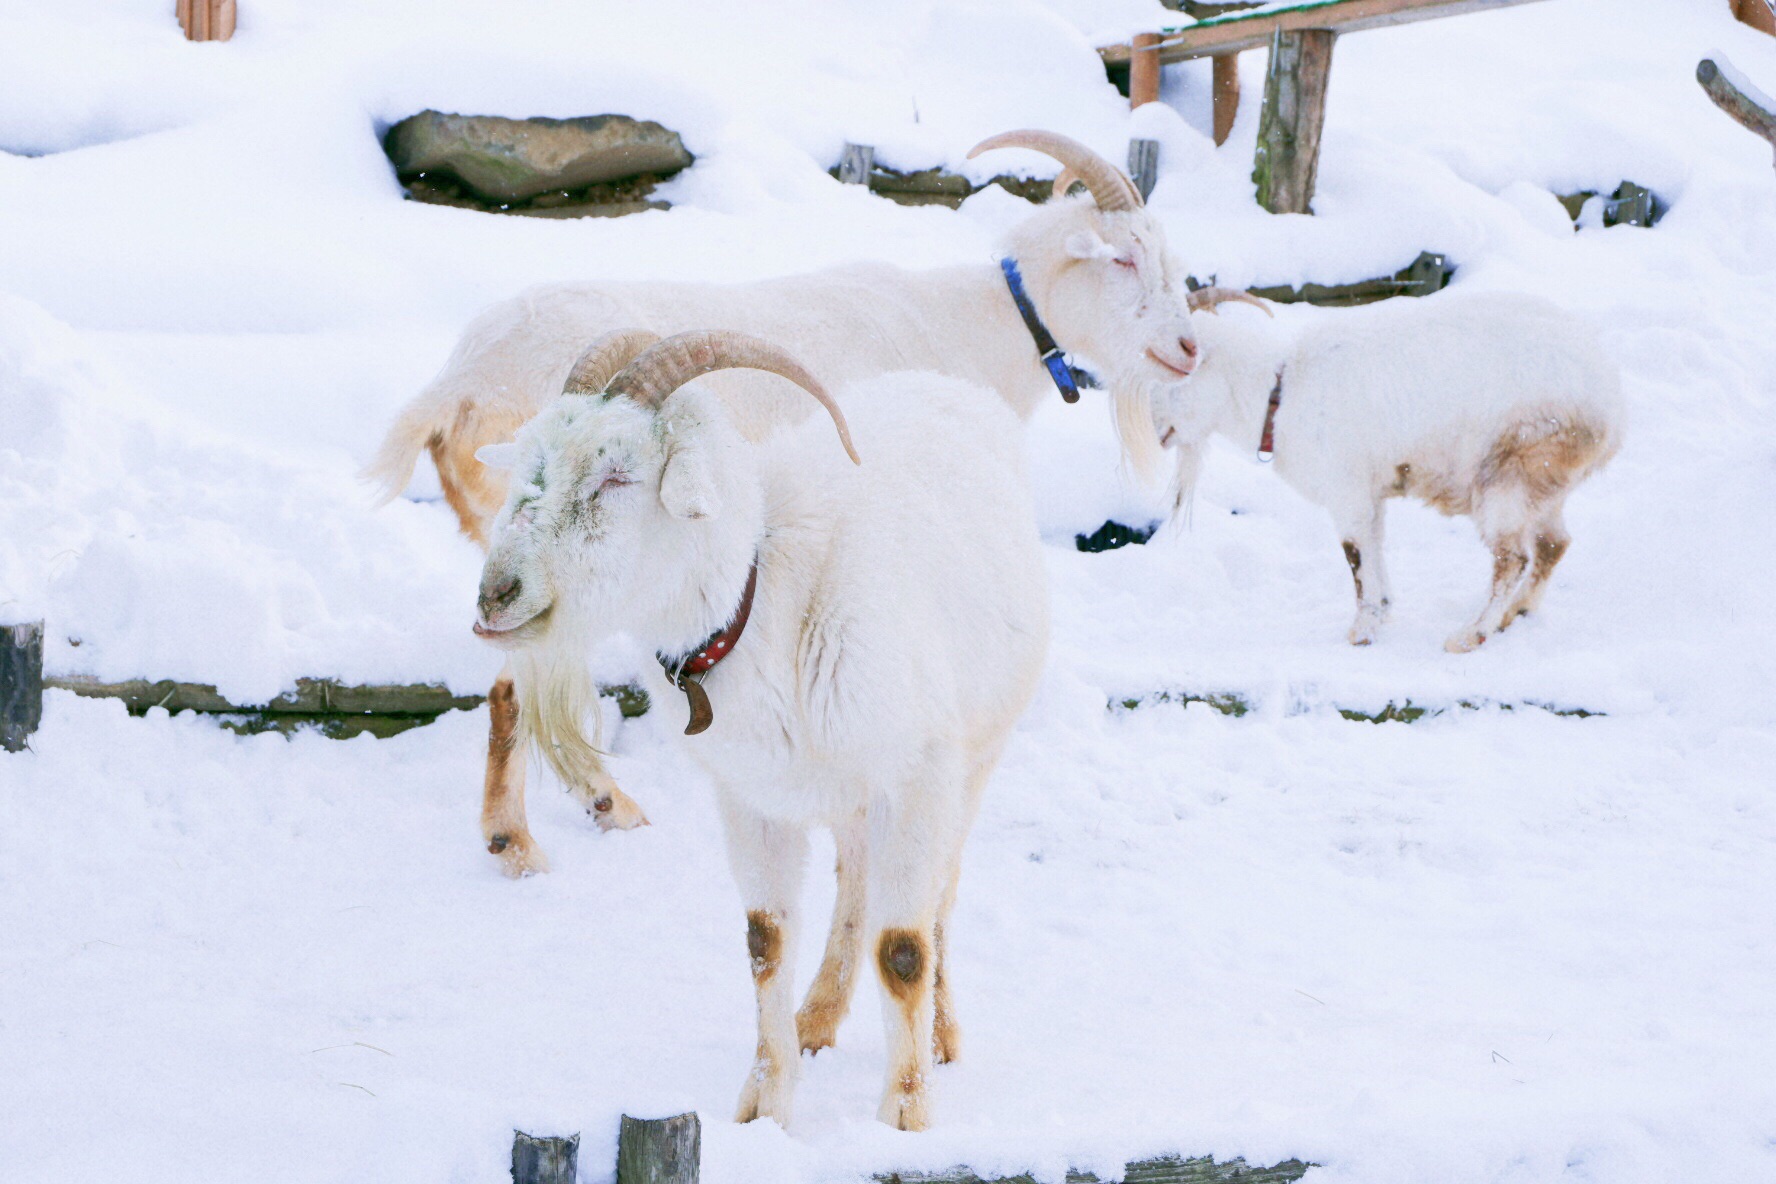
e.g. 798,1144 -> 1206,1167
1252,28 -> 1337,213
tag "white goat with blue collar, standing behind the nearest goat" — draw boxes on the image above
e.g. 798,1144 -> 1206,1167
368,131 -> 1197,875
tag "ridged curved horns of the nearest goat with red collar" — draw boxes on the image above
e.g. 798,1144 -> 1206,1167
563,328 -> 863,465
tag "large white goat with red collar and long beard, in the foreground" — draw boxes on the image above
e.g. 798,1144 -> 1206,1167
476,334 -> 1048,1129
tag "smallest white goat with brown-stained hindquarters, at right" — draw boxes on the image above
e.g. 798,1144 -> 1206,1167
1153,291 -> 1625,651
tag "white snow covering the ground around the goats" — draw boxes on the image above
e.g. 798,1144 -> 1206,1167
0,0 -> 1776,1184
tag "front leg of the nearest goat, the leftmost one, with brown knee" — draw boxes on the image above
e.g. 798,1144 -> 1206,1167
721,795 -> 808,1129
